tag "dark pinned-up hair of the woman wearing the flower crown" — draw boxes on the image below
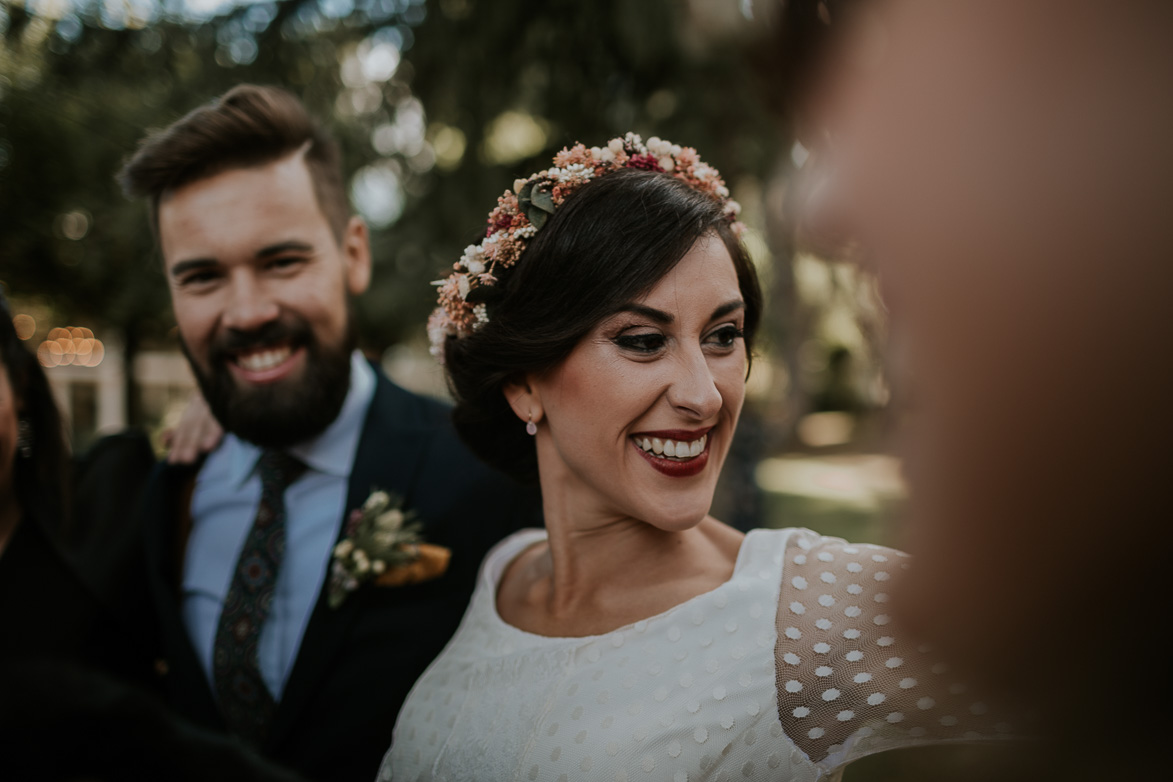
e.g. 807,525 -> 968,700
443,169 -> 761,483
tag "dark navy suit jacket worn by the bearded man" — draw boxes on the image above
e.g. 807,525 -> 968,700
142,368 -> 541,782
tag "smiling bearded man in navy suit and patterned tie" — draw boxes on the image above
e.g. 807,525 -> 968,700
120,84 -> 541,782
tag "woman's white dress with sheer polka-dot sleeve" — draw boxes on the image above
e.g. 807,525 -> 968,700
379,530 -> 1005,782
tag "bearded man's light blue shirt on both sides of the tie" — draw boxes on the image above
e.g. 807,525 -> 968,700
182,352 -> 375,700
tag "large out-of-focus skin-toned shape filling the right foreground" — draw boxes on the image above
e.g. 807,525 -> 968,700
788,0 -> 1173,778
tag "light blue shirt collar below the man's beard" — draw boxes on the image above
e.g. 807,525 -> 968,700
223,351 -> 375,487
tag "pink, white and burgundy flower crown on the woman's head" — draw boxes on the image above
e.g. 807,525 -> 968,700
428,132 -> 745,361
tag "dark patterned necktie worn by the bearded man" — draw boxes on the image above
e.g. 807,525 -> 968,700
212,450 -> 305,744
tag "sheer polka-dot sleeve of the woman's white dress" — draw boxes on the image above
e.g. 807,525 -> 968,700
775,530 -> 1009,769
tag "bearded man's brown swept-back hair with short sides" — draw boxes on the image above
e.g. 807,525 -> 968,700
117,84 -> 351,242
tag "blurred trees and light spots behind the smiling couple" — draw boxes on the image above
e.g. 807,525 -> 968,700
0,0 -> 1008,780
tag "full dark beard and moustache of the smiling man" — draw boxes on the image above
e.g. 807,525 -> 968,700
179,312 -> 358,448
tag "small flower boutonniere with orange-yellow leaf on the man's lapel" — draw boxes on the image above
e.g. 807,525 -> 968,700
327,491 -> 452,608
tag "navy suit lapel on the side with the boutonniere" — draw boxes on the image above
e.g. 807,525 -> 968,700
267,367 -> 430,746
